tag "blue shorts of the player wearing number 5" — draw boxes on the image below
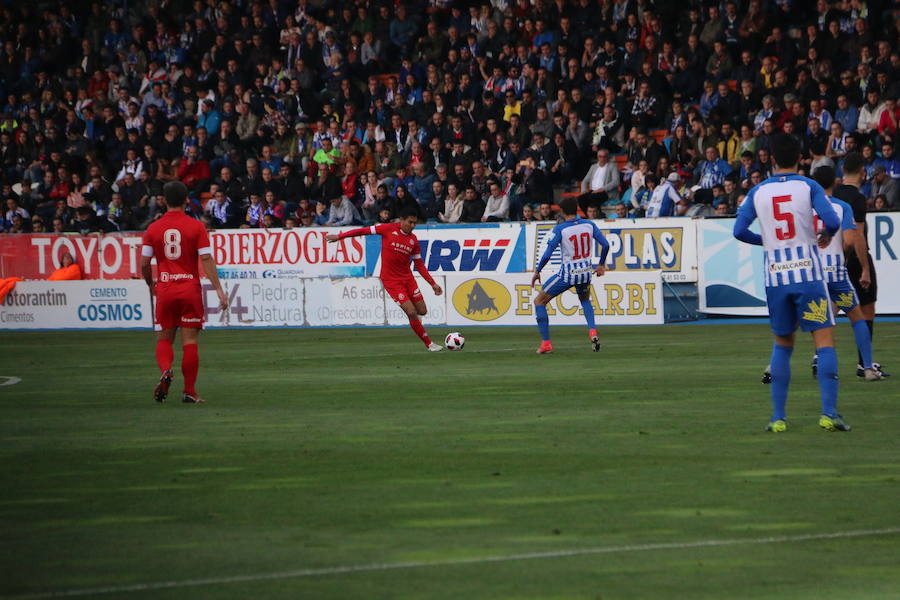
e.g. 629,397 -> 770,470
766,281 -> 834,335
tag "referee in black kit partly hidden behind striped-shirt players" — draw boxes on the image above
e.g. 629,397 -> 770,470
832,152 -> 888,377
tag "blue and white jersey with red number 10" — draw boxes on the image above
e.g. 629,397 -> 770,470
536,217 -> 609,285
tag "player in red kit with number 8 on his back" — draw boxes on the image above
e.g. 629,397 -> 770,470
141,181 -> 228,404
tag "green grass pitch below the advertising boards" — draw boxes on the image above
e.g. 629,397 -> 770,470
0,323 -> 900,600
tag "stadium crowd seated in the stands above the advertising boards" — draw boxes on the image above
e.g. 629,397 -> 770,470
0,0 -> 900,233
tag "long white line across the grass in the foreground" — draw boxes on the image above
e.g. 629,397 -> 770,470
3,527 -> 900,600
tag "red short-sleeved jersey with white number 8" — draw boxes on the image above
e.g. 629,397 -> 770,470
141,210 -> 212,293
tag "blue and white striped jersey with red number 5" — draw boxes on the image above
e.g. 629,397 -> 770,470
735,173 -> 840,287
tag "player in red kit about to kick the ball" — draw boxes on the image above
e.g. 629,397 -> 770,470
326,210 -> 444,352
